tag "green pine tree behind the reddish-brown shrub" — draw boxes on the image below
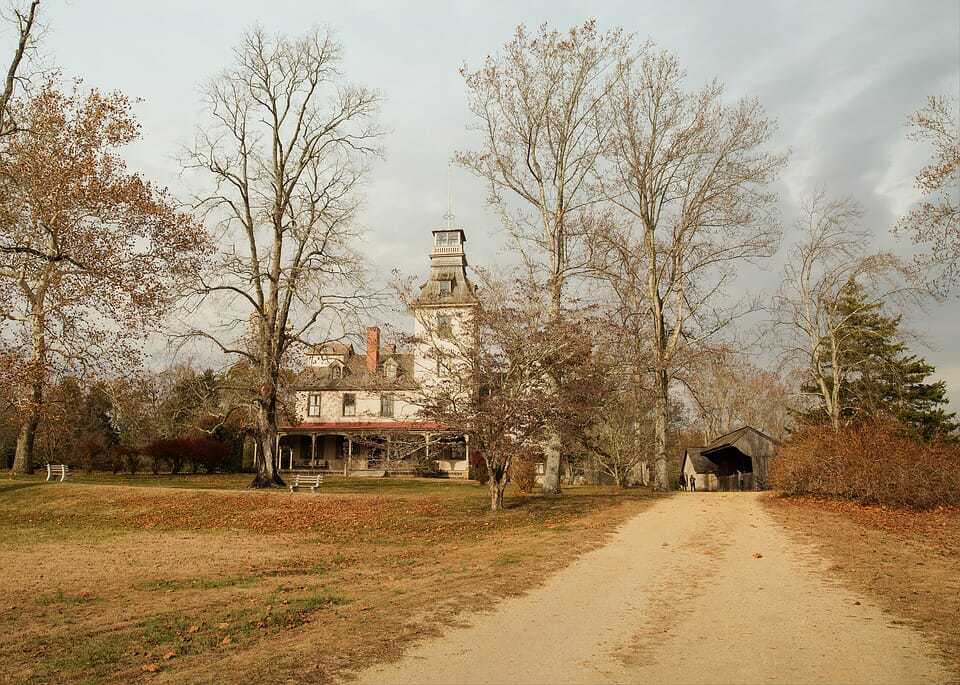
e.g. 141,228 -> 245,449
800,281 -> 960,440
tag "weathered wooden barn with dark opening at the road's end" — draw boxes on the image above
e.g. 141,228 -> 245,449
680,426 -> 779,492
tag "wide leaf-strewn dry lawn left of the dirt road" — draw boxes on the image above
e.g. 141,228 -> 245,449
0,476 -> 654,683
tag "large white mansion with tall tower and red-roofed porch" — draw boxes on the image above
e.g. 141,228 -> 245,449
279,228 -> 479,477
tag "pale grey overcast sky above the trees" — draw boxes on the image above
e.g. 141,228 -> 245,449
15,0 -> 960,409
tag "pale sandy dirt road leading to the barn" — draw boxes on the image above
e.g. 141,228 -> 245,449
348,493 -> 951,685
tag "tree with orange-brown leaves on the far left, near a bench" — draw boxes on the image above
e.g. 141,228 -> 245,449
0,81 -> 205,472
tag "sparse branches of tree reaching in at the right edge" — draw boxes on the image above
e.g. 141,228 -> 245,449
895,97 -> 960,290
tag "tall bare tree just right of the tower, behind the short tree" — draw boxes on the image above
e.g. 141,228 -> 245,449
457,20 -> 629,492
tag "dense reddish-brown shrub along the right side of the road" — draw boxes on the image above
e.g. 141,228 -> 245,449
770,418 -> 960,509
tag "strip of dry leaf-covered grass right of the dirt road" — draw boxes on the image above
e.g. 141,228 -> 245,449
765,497 -> 960,682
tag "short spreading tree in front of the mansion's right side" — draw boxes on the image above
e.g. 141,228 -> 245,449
404,275 -> 598,511
